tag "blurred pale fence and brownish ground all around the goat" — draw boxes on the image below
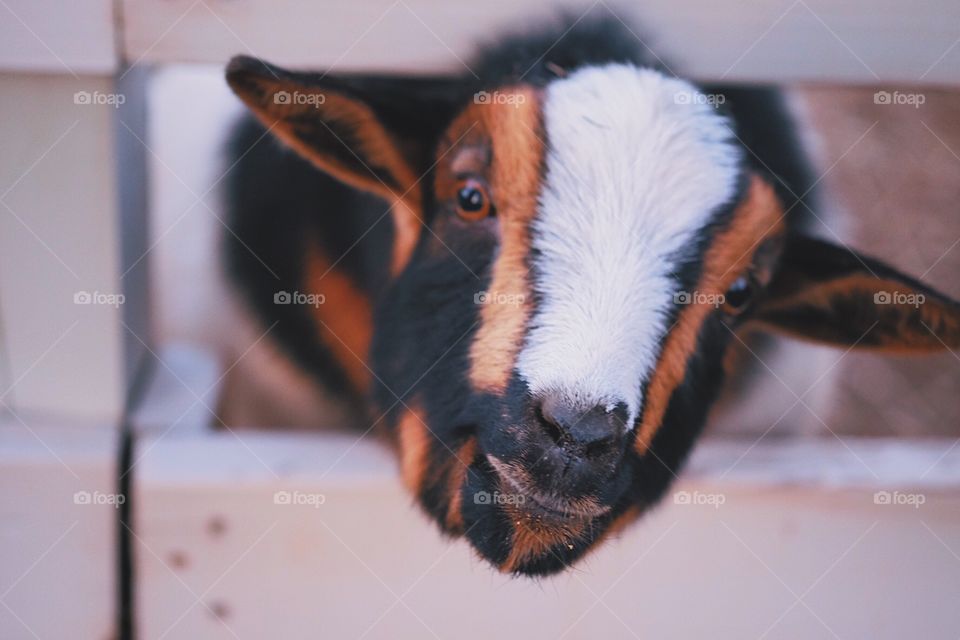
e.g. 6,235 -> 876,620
0,0 -> 960,640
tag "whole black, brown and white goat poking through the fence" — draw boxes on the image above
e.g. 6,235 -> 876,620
219,19 -> 960,575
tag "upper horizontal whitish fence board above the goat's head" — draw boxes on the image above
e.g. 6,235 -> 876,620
123,0 -> 960,84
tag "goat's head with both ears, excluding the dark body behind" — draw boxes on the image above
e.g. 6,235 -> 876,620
228,58 -> 960,574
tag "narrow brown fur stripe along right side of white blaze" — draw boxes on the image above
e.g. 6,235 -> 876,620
634,177 -> 783,455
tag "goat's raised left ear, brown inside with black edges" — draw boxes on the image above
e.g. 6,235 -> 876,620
227,56 -> 419,206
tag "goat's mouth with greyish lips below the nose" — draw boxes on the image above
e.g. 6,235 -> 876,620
487,455 -> 610,520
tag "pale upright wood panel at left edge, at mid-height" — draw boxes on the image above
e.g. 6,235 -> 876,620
0,74 -> 149,425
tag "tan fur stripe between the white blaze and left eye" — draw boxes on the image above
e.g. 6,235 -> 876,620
437,87 -> 544,392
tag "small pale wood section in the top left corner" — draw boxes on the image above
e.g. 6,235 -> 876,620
0,0 -> 117,76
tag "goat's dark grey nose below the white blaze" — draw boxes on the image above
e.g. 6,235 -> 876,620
540,396 -> 627,459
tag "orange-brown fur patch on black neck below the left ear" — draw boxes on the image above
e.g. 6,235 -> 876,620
304,247 -> 373,392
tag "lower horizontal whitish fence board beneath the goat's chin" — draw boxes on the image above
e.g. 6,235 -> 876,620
132,348 -> 960,640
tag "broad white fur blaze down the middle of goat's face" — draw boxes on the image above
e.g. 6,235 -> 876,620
517,64 -> 741,425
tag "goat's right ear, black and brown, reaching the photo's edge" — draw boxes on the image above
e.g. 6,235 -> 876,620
751,236 -> 960,352
